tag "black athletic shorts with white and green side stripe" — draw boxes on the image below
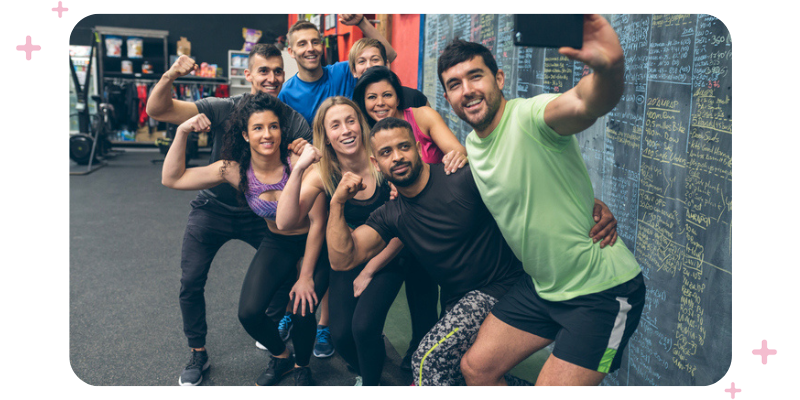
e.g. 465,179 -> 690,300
492,274 -> 645,373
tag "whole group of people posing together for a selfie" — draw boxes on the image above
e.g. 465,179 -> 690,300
147,14 -> 645,386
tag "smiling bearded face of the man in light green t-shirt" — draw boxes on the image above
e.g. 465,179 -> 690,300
442,56 -> 505,132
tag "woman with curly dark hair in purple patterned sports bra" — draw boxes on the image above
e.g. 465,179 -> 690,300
161,93 -> 330,386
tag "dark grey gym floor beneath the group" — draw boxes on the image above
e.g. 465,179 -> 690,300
69,148 -> 549,386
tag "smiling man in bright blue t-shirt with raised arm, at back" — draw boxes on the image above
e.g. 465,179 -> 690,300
278,14 -> 397,126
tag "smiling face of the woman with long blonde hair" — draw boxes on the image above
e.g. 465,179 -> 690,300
324,104 -> 364,155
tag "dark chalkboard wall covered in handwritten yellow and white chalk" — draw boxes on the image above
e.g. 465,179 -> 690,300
421,15 -> 732,385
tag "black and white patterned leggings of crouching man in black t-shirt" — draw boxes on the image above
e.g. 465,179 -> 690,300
411,290 -> 531,386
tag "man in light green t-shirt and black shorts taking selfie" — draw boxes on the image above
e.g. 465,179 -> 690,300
438,15 -> 645,385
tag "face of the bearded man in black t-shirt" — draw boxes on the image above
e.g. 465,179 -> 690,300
371,128 -> 422,187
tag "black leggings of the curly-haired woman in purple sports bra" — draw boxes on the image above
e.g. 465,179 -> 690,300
239,231 -> 330,366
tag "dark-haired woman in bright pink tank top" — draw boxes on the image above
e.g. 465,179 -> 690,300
353,66 -> 467,171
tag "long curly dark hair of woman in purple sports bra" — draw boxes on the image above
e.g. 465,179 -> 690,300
220,92 -> 289,204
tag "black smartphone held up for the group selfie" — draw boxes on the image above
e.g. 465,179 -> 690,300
514,14 -> 583,49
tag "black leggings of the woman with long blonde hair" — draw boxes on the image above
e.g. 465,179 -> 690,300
328,258 -> 404,386
